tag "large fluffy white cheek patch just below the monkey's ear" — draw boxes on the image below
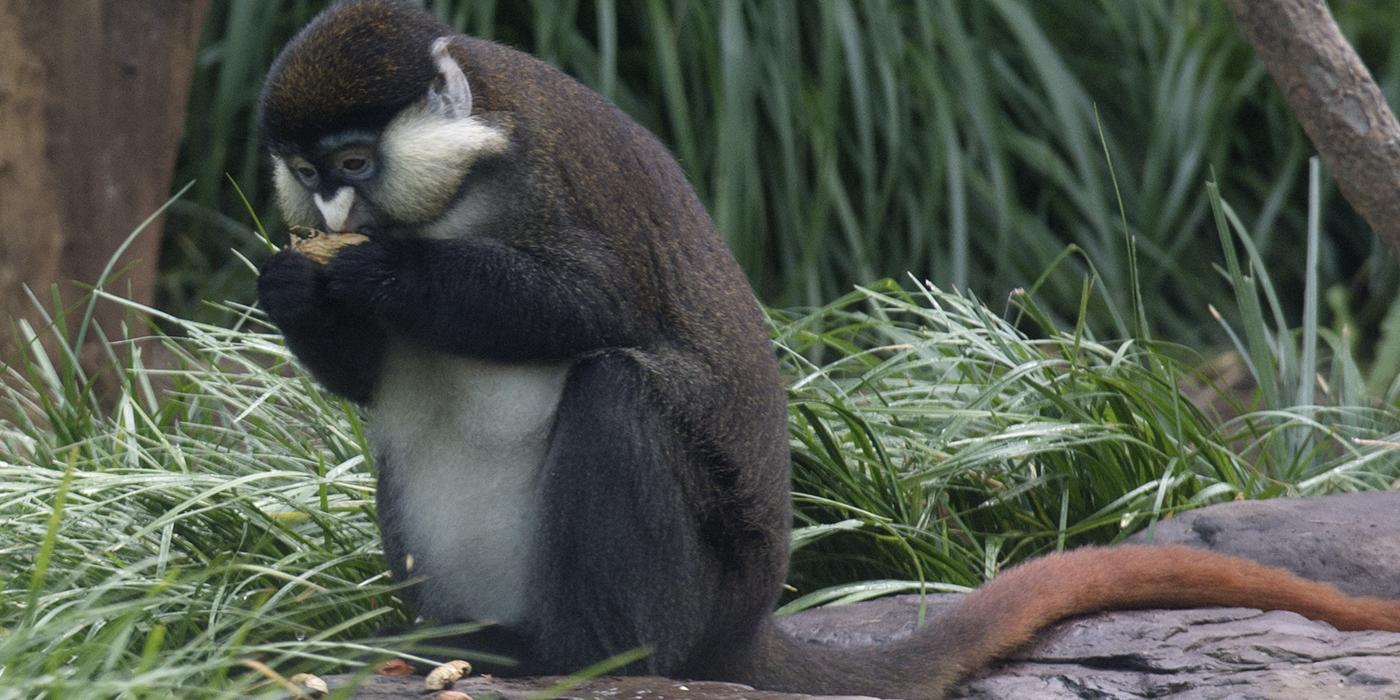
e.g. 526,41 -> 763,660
374,105 -> 510,224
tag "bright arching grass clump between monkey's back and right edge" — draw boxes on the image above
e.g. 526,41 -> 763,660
776,162 -> 1400,609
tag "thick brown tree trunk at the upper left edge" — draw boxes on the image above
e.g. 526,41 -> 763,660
0,0 -> 209,389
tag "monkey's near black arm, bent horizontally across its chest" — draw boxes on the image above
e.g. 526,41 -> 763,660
326,237 -> 640,361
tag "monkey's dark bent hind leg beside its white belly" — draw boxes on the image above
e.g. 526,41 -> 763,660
524,353 -> 724,673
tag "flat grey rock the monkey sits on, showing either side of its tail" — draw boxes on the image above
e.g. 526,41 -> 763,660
328,595 -> 1400,700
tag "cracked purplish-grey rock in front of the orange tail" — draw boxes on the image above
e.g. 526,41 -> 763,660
953,608 -> 1400,700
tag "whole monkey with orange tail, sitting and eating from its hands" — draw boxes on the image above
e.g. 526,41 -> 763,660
258,0 -> 1400,699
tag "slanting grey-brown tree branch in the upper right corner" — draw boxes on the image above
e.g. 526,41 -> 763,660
1225,0 -> 1400,260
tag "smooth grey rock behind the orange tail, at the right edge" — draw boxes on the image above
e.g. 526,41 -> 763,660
1128,491 -> 1400,598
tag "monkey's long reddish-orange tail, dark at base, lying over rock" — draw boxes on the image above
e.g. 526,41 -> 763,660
743,545 -> 1400,699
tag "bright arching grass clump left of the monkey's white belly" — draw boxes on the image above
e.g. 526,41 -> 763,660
0,293 -> 448,697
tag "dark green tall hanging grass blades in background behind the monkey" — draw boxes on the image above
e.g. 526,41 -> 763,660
162,0 -> 1400,354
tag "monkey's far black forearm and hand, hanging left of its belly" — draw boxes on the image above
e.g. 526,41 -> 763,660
258,251 -> 385,403
